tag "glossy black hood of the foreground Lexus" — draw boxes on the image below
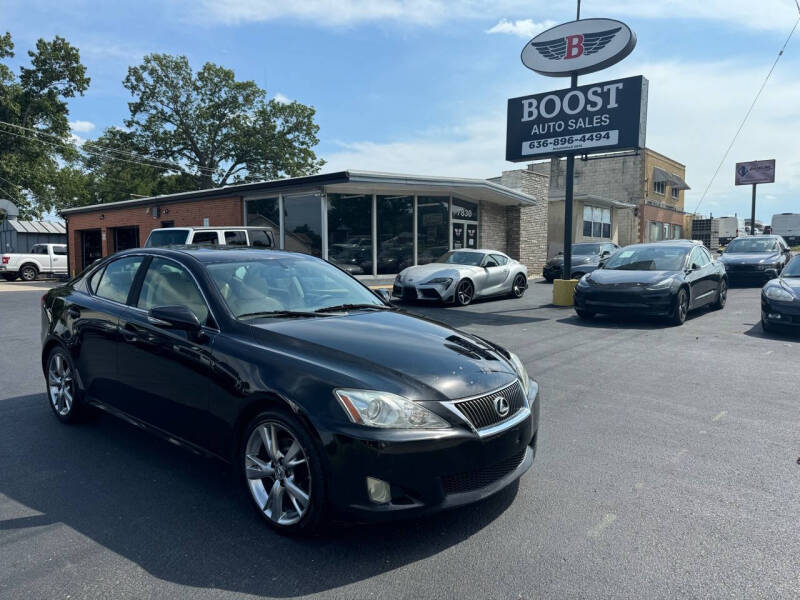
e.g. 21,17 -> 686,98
251,311 -> 517,400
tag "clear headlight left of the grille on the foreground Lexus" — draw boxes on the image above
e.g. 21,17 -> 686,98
334,390 -> 450,429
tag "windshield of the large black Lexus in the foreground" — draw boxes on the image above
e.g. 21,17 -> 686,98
207,256 -> 386,318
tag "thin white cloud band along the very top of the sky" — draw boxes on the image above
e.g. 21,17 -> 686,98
192,0 -> 797,31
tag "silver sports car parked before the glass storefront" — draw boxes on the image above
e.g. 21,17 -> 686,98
392,250 -> 528,306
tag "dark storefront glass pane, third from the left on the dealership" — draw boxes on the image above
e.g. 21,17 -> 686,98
328,194 -> 372,275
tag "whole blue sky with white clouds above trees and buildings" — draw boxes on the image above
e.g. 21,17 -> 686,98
0,0 -> 800,219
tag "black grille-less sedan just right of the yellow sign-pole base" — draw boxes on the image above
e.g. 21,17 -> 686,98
575,240 -> 728,325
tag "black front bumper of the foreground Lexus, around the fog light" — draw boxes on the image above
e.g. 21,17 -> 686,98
326,384 -> 539,521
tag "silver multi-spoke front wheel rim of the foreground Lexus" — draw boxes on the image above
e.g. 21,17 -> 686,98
244,421 -> 311,525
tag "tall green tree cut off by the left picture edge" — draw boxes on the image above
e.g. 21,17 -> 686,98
0,33 -> 90,217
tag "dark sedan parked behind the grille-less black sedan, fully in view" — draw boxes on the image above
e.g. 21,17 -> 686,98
719,235 -> 792,285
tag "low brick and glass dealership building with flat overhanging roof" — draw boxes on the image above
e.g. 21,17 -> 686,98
61,170 -> 548,278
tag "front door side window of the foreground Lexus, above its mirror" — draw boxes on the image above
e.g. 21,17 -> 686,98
136,258 -> 208,323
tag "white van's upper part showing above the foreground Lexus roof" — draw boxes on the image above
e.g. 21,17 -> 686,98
144,227 -> 277,248
